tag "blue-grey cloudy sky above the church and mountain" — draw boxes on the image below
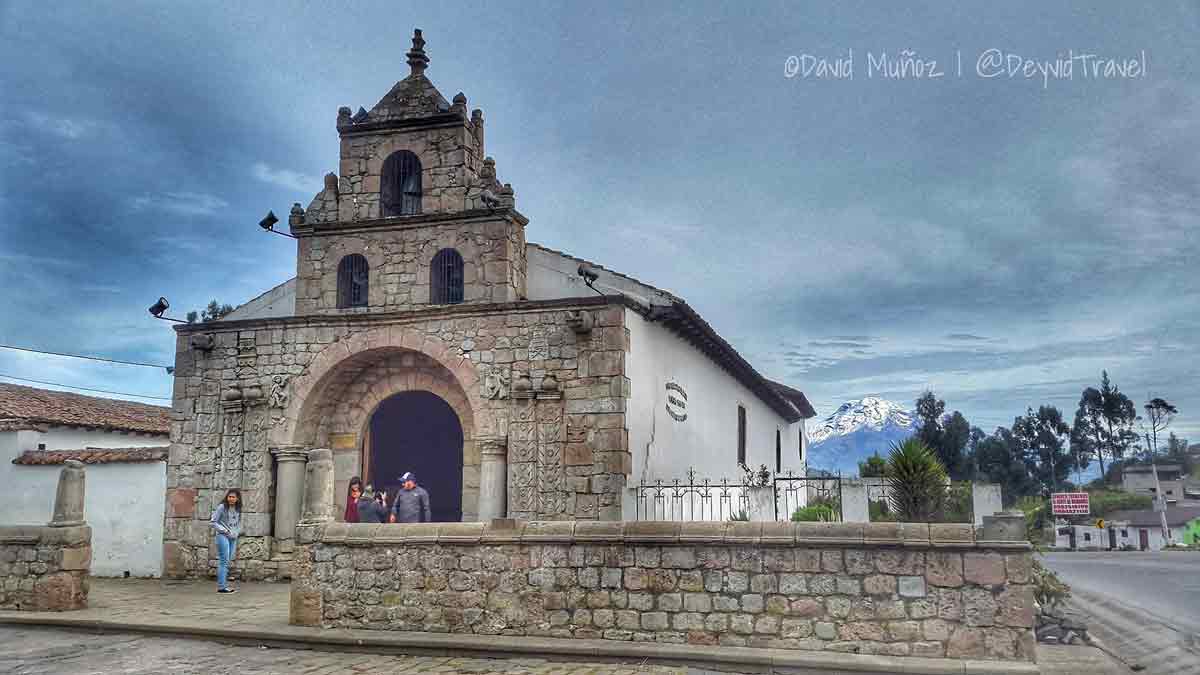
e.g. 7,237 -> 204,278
0,0 -> 1200,441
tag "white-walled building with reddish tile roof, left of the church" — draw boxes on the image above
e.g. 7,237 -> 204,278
0,383 -> 170,577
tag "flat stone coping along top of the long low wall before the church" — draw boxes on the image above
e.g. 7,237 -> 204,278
302,520 -> 1032,551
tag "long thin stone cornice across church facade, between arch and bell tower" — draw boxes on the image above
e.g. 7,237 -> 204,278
173,295 -> 646,335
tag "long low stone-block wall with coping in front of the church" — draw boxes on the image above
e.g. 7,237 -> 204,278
292,520 -> 1034,661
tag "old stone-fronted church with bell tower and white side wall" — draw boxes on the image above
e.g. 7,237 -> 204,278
163,30 -> 815,579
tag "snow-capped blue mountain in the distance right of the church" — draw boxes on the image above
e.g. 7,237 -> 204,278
809,396 -> 917,476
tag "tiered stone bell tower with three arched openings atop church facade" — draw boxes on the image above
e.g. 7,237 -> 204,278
288,30 -> 528,316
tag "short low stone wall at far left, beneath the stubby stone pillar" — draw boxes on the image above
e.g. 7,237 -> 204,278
0,525 -> 91,611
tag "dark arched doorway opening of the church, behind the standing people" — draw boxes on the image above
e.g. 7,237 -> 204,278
362,392 -> 463,522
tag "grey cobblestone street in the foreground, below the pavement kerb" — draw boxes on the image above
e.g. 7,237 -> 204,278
0,626 -> 688,675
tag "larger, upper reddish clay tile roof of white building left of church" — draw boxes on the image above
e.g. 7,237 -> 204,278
0,383 -> 170,435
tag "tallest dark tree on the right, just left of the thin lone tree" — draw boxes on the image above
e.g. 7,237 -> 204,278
1070,370 -> 1138,476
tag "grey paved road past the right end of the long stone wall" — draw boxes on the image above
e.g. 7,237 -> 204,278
1044,551 -> 1200,675
